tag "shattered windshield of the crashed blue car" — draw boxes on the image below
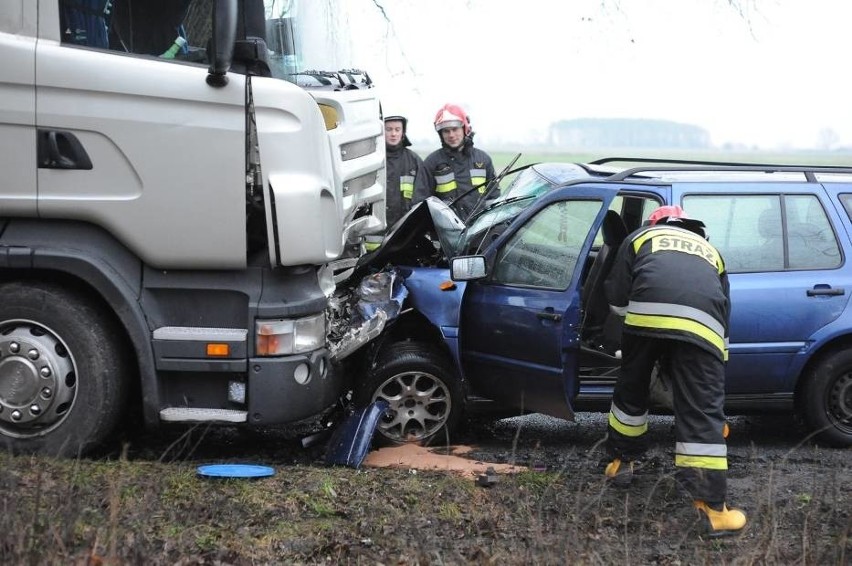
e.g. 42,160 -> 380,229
447,163 -> 589,256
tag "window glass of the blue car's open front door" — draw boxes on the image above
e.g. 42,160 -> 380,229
492,200 -> 602,289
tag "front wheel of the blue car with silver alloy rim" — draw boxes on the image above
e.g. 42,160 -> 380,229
355,342 -> 464,444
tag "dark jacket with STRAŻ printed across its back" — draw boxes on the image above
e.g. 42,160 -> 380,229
604,224 -> 731,360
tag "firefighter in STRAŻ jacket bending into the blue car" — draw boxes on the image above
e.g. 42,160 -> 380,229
605,206 -> 746,536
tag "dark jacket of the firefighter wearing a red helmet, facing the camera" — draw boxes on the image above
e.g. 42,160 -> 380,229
413,143 -> 500,220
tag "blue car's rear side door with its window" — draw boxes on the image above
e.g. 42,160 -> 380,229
672,182 -> 852,403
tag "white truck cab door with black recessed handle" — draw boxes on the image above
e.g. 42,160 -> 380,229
33,0 -> 246,269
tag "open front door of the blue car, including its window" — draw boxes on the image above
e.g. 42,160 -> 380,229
460,187 -> 615,419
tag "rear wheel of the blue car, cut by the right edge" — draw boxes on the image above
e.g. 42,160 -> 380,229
802,350 -> 852,446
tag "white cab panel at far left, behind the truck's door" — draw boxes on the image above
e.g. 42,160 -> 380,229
0,0 -> 37,216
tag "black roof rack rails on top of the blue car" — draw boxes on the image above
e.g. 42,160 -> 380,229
589,157 -> 852,183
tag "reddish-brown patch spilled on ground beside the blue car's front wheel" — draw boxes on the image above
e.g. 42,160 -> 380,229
363,444 -> 527,476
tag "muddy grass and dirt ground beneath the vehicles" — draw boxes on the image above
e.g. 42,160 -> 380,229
0,414 -> 852,565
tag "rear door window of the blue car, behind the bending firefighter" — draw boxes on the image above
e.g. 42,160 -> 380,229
683,194 -> 841,273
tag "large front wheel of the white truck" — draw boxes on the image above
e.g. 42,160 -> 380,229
0,282 -> 128,456
